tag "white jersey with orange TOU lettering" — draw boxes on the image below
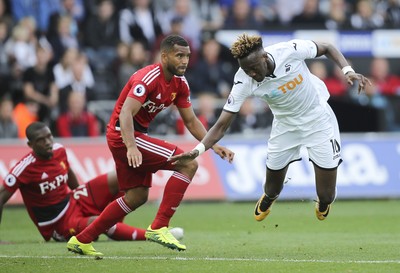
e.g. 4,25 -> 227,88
224,40 -> 330,126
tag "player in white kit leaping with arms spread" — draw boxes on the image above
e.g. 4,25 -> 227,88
170,34 -> 371,221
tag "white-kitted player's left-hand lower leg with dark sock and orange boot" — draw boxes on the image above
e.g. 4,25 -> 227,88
254,166 -> 288,221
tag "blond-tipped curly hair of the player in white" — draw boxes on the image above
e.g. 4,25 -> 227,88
231,33 -> 263,59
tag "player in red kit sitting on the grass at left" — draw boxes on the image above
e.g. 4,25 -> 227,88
0,122 -> 180,241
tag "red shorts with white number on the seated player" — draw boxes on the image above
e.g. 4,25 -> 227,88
55,174 -> 116,240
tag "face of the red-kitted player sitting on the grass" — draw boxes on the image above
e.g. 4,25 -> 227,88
28,127 -> 53,159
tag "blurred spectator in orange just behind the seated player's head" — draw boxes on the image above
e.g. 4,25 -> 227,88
13,99 -> 39,138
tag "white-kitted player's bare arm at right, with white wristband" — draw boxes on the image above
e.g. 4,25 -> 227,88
315,42 -> 371,93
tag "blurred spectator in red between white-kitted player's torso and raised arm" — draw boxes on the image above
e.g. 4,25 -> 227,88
309,60 -> 348,97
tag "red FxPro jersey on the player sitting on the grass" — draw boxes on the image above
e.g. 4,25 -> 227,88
4,143 -> 70,234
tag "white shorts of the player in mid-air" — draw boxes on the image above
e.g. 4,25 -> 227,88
266,105 -> 342,170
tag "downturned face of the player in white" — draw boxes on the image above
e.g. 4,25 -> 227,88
239,50 -> 270,82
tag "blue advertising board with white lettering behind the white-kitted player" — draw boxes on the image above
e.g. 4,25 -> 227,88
214,136 -> 400,200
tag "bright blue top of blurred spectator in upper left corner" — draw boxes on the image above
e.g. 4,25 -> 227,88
10,0 -> 60,33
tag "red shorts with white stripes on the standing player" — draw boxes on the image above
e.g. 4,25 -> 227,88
107,132 -> 183,191
